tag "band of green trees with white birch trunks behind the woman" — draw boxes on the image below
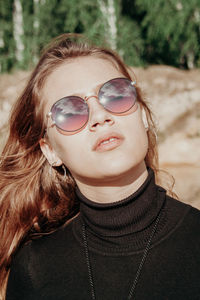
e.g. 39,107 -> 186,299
0,0 -> 200,72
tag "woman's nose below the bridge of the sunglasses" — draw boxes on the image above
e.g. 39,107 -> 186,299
87,96 -> 114,131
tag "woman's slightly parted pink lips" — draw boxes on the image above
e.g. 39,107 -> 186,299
93,133 -> 124,152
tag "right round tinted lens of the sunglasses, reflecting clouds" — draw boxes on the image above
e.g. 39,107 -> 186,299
99,78 -> 137,113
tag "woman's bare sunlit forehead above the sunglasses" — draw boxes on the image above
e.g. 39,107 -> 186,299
43,56 -> 122,108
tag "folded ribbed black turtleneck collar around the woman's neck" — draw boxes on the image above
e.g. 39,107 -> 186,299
76,169 -> 164,237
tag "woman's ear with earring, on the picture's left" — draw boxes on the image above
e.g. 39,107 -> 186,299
39,138 -> 62,167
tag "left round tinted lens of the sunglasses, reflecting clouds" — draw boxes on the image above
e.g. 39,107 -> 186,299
51,96 -> 88,131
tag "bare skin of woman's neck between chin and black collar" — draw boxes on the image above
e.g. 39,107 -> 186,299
73,163 -> 148,203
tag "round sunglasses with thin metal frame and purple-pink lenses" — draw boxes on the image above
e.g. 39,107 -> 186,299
47,78 -> 137,132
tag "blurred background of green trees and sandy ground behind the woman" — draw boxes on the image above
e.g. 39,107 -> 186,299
0,0 -> 200,208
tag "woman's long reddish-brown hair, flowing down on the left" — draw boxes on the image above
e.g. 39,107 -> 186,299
0,34 -> 158,299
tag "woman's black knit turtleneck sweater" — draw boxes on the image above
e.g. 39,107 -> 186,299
6,170 -> 200,300
